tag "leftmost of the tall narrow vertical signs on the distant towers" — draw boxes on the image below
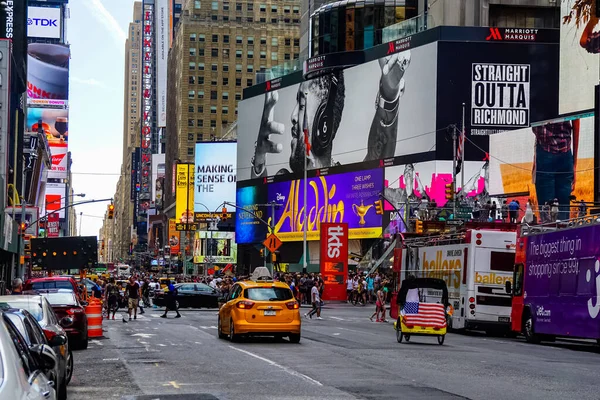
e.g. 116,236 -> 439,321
139,3 -> 154,214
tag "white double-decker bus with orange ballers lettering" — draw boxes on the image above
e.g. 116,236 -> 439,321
394,229 -> 517,333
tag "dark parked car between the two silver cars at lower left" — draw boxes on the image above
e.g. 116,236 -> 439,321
3,308 -> 73,400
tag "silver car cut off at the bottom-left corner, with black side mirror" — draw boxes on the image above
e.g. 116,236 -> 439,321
0,312 -> 56,400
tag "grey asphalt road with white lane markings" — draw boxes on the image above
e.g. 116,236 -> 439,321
69,304 -> 600,400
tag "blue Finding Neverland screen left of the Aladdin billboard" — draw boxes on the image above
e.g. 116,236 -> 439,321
235,185 -> 268,244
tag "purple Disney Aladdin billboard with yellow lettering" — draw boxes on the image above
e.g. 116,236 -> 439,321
268,169 -> 383,242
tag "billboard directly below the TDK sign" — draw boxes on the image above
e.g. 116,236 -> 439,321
27,43 -> 71,100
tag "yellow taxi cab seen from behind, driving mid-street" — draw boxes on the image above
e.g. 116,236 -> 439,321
217,281 -> 302,343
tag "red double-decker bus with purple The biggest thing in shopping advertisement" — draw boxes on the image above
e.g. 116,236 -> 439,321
506,216 -> 600,344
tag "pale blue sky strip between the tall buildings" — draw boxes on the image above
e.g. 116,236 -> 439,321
66,0 -> 134,236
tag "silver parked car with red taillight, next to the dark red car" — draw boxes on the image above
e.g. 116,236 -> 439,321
0,295 -> 73,386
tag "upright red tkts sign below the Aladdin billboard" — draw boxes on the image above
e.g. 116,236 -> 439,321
321,222 -> 348,300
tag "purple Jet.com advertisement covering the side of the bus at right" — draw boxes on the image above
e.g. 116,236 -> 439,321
524,225 -> 600,338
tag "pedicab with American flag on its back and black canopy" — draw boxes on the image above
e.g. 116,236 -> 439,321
394,277 -> 450,345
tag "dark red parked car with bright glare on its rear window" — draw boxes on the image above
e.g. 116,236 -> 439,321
36,289 -> 88,349
